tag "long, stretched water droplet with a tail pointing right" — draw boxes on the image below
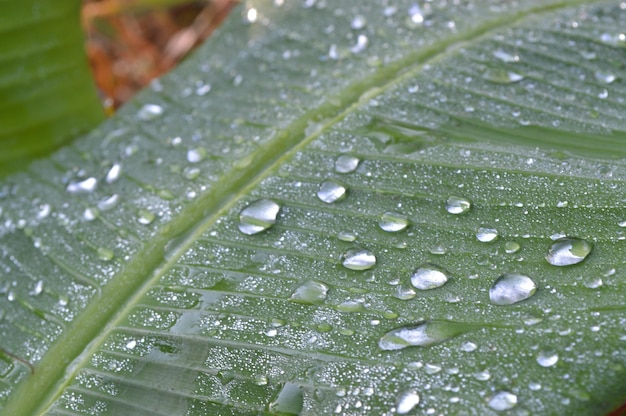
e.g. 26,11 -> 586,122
378,320 -> 479,351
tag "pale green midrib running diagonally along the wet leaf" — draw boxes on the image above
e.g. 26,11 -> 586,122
4,0 -> 586,415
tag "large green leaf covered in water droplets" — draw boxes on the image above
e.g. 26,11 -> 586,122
0,0 -> 626,415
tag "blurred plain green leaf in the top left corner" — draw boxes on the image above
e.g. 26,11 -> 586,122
0,0 -> 104,174
